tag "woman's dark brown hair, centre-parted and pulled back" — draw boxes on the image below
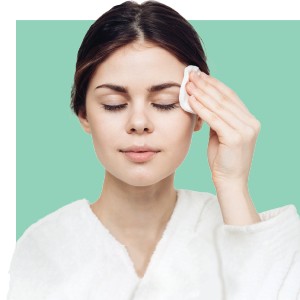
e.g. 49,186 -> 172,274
71,1 -> 209,116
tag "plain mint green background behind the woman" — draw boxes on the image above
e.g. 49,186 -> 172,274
17,21 -> 300,238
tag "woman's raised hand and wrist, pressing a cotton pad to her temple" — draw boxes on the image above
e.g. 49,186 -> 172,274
186,72 -> 260,224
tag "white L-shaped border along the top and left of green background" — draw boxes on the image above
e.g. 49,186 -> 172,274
0,0 -> 300,299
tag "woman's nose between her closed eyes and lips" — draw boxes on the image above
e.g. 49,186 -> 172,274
126,106 -> 154,134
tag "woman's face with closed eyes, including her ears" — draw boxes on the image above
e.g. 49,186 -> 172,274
79,42 -> 201,186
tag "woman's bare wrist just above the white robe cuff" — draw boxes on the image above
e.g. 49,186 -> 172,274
217,183 -> 261,226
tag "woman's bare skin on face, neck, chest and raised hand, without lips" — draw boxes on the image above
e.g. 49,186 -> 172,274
79,41 -> 260,276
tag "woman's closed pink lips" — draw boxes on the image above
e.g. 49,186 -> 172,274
120,146 -> 160,163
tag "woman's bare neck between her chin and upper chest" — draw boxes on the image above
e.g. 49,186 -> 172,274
91,172 -> 177,240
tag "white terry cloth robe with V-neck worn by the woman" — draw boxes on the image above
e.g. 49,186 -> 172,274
8,190 -> 300,300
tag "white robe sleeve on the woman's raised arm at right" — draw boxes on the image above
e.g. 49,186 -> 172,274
217,205 -> 300,300
